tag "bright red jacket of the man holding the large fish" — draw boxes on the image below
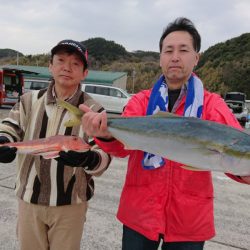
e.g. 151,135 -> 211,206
96,90 -> 244,242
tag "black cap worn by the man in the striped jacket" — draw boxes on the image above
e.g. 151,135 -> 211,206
51,39 -> 88,68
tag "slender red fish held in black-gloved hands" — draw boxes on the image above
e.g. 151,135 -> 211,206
0,135 -> 90,159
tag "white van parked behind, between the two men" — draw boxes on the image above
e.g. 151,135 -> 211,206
82,84 -> 131,114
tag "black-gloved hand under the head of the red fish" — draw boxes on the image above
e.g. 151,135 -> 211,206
55,150 -> 99,170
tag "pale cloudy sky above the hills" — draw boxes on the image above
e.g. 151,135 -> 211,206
0,0 -> 250,55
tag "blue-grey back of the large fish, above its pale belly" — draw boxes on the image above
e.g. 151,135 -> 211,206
108,116 -> 250,149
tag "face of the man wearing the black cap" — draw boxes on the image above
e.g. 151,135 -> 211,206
49,51 -> 88,88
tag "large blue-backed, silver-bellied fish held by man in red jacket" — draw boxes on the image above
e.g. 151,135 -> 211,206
57,98 -> 250,176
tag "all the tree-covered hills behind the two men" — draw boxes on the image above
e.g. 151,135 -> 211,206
0,33 -> 250,96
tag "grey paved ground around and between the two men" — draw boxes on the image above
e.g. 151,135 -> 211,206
0,108 -> 250,250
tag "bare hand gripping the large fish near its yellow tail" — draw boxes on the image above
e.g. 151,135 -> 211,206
79,104 -> 113,140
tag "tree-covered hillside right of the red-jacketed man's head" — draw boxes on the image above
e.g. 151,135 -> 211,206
196,33 -> 250,98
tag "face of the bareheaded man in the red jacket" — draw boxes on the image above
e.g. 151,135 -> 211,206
160,31 -> 199,89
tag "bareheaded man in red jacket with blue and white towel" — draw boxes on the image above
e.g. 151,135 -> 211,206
80,18 -> 249,250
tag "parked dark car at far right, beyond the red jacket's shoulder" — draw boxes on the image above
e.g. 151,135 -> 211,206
224,92 -> 248,127
